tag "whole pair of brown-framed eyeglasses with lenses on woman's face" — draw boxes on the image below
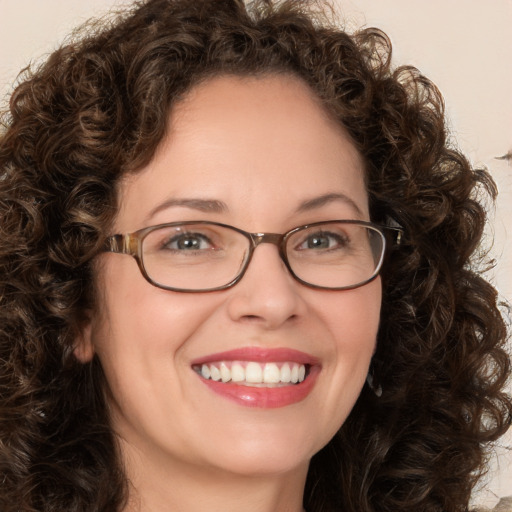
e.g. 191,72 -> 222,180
104,220 -> 402,292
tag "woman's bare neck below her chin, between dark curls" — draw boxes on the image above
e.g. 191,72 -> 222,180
123,440 -> 308,512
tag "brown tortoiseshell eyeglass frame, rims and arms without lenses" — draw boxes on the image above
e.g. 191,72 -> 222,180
102,219 -> 403,293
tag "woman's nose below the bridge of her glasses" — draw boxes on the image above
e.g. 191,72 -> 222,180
228,243 -> 306,329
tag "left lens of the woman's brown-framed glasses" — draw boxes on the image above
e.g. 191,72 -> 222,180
142,223 -> 250,290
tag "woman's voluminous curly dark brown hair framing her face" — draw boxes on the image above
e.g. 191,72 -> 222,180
0,0 -> 512,512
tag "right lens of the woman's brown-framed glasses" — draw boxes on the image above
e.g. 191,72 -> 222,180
286,222 -> 385,288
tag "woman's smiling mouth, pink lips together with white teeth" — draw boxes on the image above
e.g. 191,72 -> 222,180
192,347 -> 320,408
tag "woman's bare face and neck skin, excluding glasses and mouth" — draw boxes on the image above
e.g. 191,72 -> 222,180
76,76 -> 381,512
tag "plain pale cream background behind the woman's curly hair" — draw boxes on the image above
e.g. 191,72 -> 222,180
0,0 -> 512,505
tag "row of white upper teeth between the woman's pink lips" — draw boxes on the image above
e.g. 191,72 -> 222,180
201,361 -> 306,384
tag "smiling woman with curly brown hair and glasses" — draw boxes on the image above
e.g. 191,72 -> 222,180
0,0 -> 512,512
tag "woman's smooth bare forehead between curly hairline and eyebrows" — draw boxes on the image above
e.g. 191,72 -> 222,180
119,75 -> 367,229
